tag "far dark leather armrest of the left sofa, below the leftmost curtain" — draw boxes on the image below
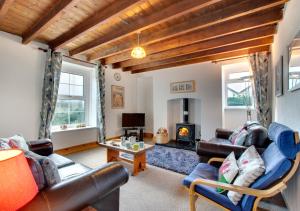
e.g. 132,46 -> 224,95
27,139 -> 53,156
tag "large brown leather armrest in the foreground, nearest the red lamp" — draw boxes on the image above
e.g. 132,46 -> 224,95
21,163 -> 129,211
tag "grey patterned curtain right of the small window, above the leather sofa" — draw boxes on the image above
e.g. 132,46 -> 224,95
249,52 -> 272,127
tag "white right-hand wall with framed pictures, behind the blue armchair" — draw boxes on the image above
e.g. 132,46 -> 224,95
272,0 -> 300,211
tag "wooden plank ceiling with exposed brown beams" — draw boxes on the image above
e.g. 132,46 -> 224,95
0,0 -> 287,73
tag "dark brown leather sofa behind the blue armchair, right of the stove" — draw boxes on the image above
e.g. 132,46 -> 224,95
196,122 -> 270,162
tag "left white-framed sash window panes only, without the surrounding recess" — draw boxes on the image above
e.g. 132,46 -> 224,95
52,72 -> 86,126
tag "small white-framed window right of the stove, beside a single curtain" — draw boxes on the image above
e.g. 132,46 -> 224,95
225,67 -> 253,108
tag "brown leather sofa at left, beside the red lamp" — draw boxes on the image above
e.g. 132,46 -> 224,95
21,140 -> 129,211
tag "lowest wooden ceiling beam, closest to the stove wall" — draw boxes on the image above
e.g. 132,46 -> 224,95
132,45 -> 270,73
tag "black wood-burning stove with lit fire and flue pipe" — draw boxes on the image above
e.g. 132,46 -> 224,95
176,98 -> 195,143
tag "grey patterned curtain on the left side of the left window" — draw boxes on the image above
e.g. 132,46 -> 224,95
39,50 -> 62,138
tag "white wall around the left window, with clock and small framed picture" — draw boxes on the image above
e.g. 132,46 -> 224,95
0,32 -> 137,149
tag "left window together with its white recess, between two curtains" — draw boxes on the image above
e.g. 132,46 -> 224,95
52,62 -> 95,130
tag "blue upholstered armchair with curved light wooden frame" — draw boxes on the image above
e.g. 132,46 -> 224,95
183,123 -> 300,211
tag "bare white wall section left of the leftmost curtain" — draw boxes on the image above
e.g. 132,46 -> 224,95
0,32 -> 46,139
